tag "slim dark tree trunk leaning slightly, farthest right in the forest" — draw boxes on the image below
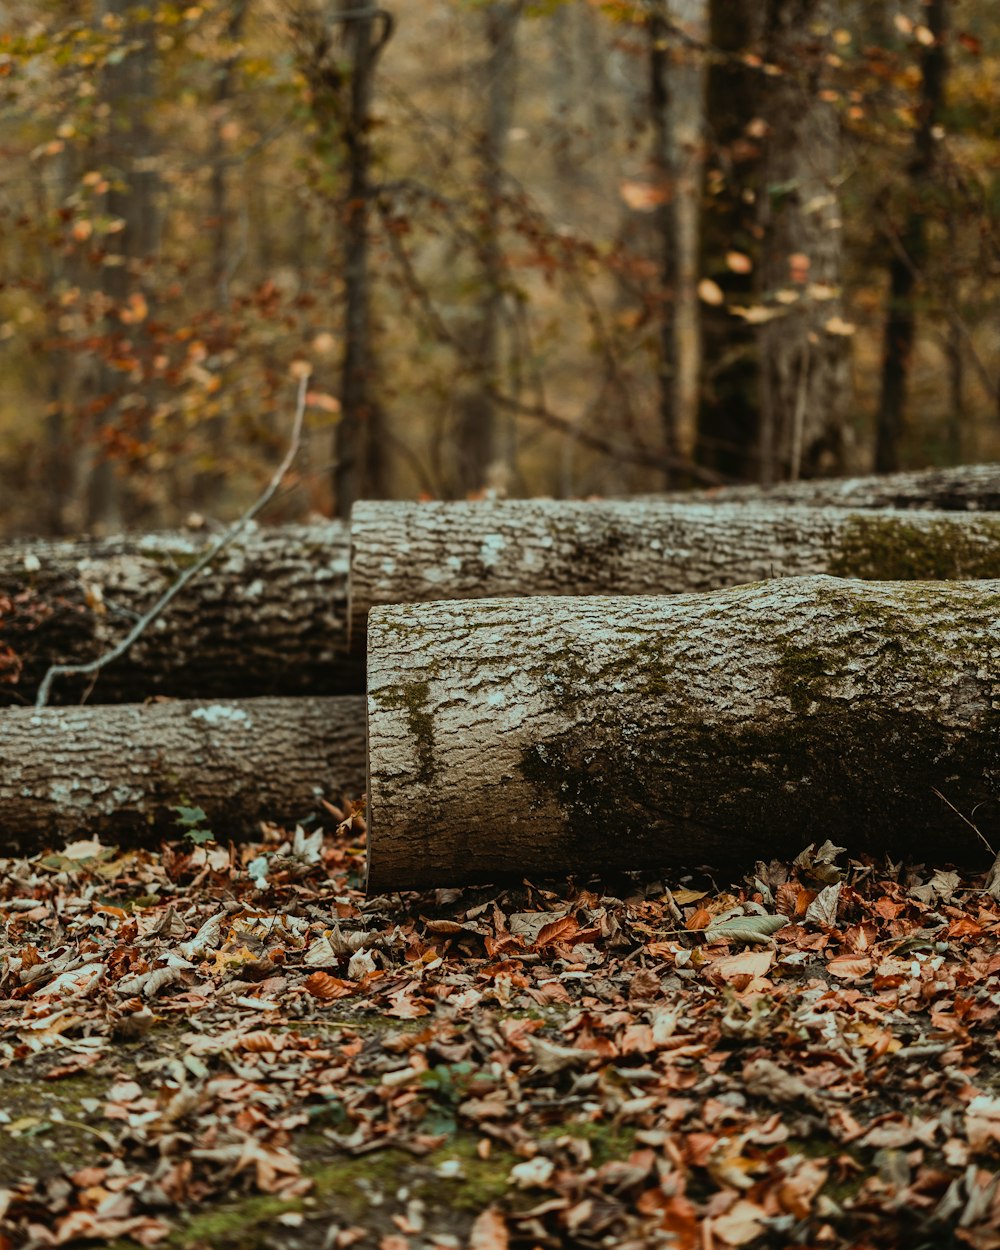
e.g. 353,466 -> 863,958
875,0 -> 949,473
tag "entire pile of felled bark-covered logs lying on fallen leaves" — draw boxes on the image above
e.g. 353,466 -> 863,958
0,466 -> 1000,870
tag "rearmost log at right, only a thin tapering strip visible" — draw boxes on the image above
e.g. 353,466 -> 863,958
659,464 -> 1000,513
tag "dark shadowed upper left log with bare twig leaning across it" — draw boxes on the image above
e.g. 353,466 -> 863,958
0,523 -> 364,704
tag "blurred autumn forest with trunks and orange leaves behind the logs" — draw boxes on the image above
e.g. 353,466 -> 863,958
0,0 -> 1000,534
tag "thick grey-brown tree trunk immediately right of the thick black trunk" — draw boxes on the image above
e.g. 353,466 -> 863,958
759,0 -> 850,483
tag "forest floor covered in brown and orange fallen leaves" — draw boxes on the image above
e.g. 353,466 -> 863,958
0,816 -> 1000,1250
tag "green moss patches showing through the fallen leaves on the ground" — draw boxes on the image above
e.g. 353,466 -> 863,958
0,1013 -> 634,1250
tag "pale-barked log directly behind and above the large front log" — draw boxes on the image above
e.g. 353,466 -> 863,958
350,500 -> 1000,643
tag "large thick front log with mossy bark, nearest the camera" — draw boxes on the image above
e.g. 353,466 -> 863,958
368,576 -> 1000,893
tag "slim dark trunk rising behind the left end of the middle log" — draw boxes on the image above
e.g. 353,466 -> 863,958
334,0 -> 393,518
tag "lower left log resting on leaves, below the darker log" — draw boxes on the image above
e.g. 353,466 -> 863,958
0,698 -> 365,855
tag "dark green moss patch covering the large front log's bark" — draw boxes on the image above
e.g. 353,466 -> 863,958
519,584 -> 1000,864
